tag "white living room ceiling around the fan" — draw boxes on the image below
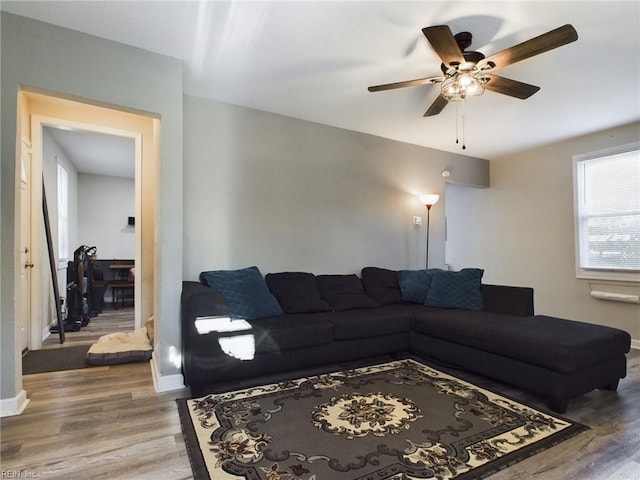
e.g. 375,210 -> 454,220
2,0 -> 640,159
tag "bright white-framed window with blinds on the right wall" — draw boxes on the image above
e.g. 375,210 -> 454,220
574,143 -> 640,281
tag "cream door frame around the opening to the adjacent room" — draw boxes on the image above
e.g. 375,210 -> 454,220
15,90 -> 154,353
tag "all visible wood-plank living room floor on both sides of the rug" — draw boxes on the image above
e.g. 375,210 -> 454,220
0,350 -> 640,480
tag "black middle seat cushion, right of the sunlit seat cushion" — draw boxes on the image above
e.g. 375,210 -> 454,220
320,305 -> 416,341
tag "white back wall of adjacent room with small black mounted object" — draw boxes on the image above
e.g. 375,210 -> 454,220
79,173 -> 135,260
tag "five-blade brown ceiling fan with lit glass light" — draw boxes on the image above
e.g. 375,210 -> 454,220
368,24 -> 578,117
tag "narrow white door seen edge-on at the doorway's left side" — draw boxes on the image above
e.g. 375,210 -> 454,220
17,139 -> 33,350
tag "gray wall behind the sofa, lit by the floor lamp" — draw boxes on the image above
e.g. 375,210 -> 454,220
184,97 -> 489,279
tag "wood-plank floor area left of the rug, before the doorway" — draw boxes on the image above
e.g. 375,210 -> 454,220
0,362 -> 192,480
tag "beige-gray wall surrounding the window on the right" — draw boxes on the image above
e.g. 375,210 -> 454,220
447,123 -> 640,347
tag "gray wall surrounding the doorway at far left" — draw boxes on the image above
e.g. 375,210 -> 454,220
0,12 -> 182,399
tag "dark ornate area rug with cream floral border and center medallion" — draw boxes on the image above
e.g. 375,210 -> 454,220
178,360 -> 588,480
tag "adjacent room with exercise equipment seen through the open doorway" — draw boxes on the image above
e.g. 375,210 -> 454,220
38,125 -> 136,352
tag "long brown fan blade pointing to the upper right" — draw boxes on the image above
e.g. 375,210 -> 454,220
482,24 -> 578,68
